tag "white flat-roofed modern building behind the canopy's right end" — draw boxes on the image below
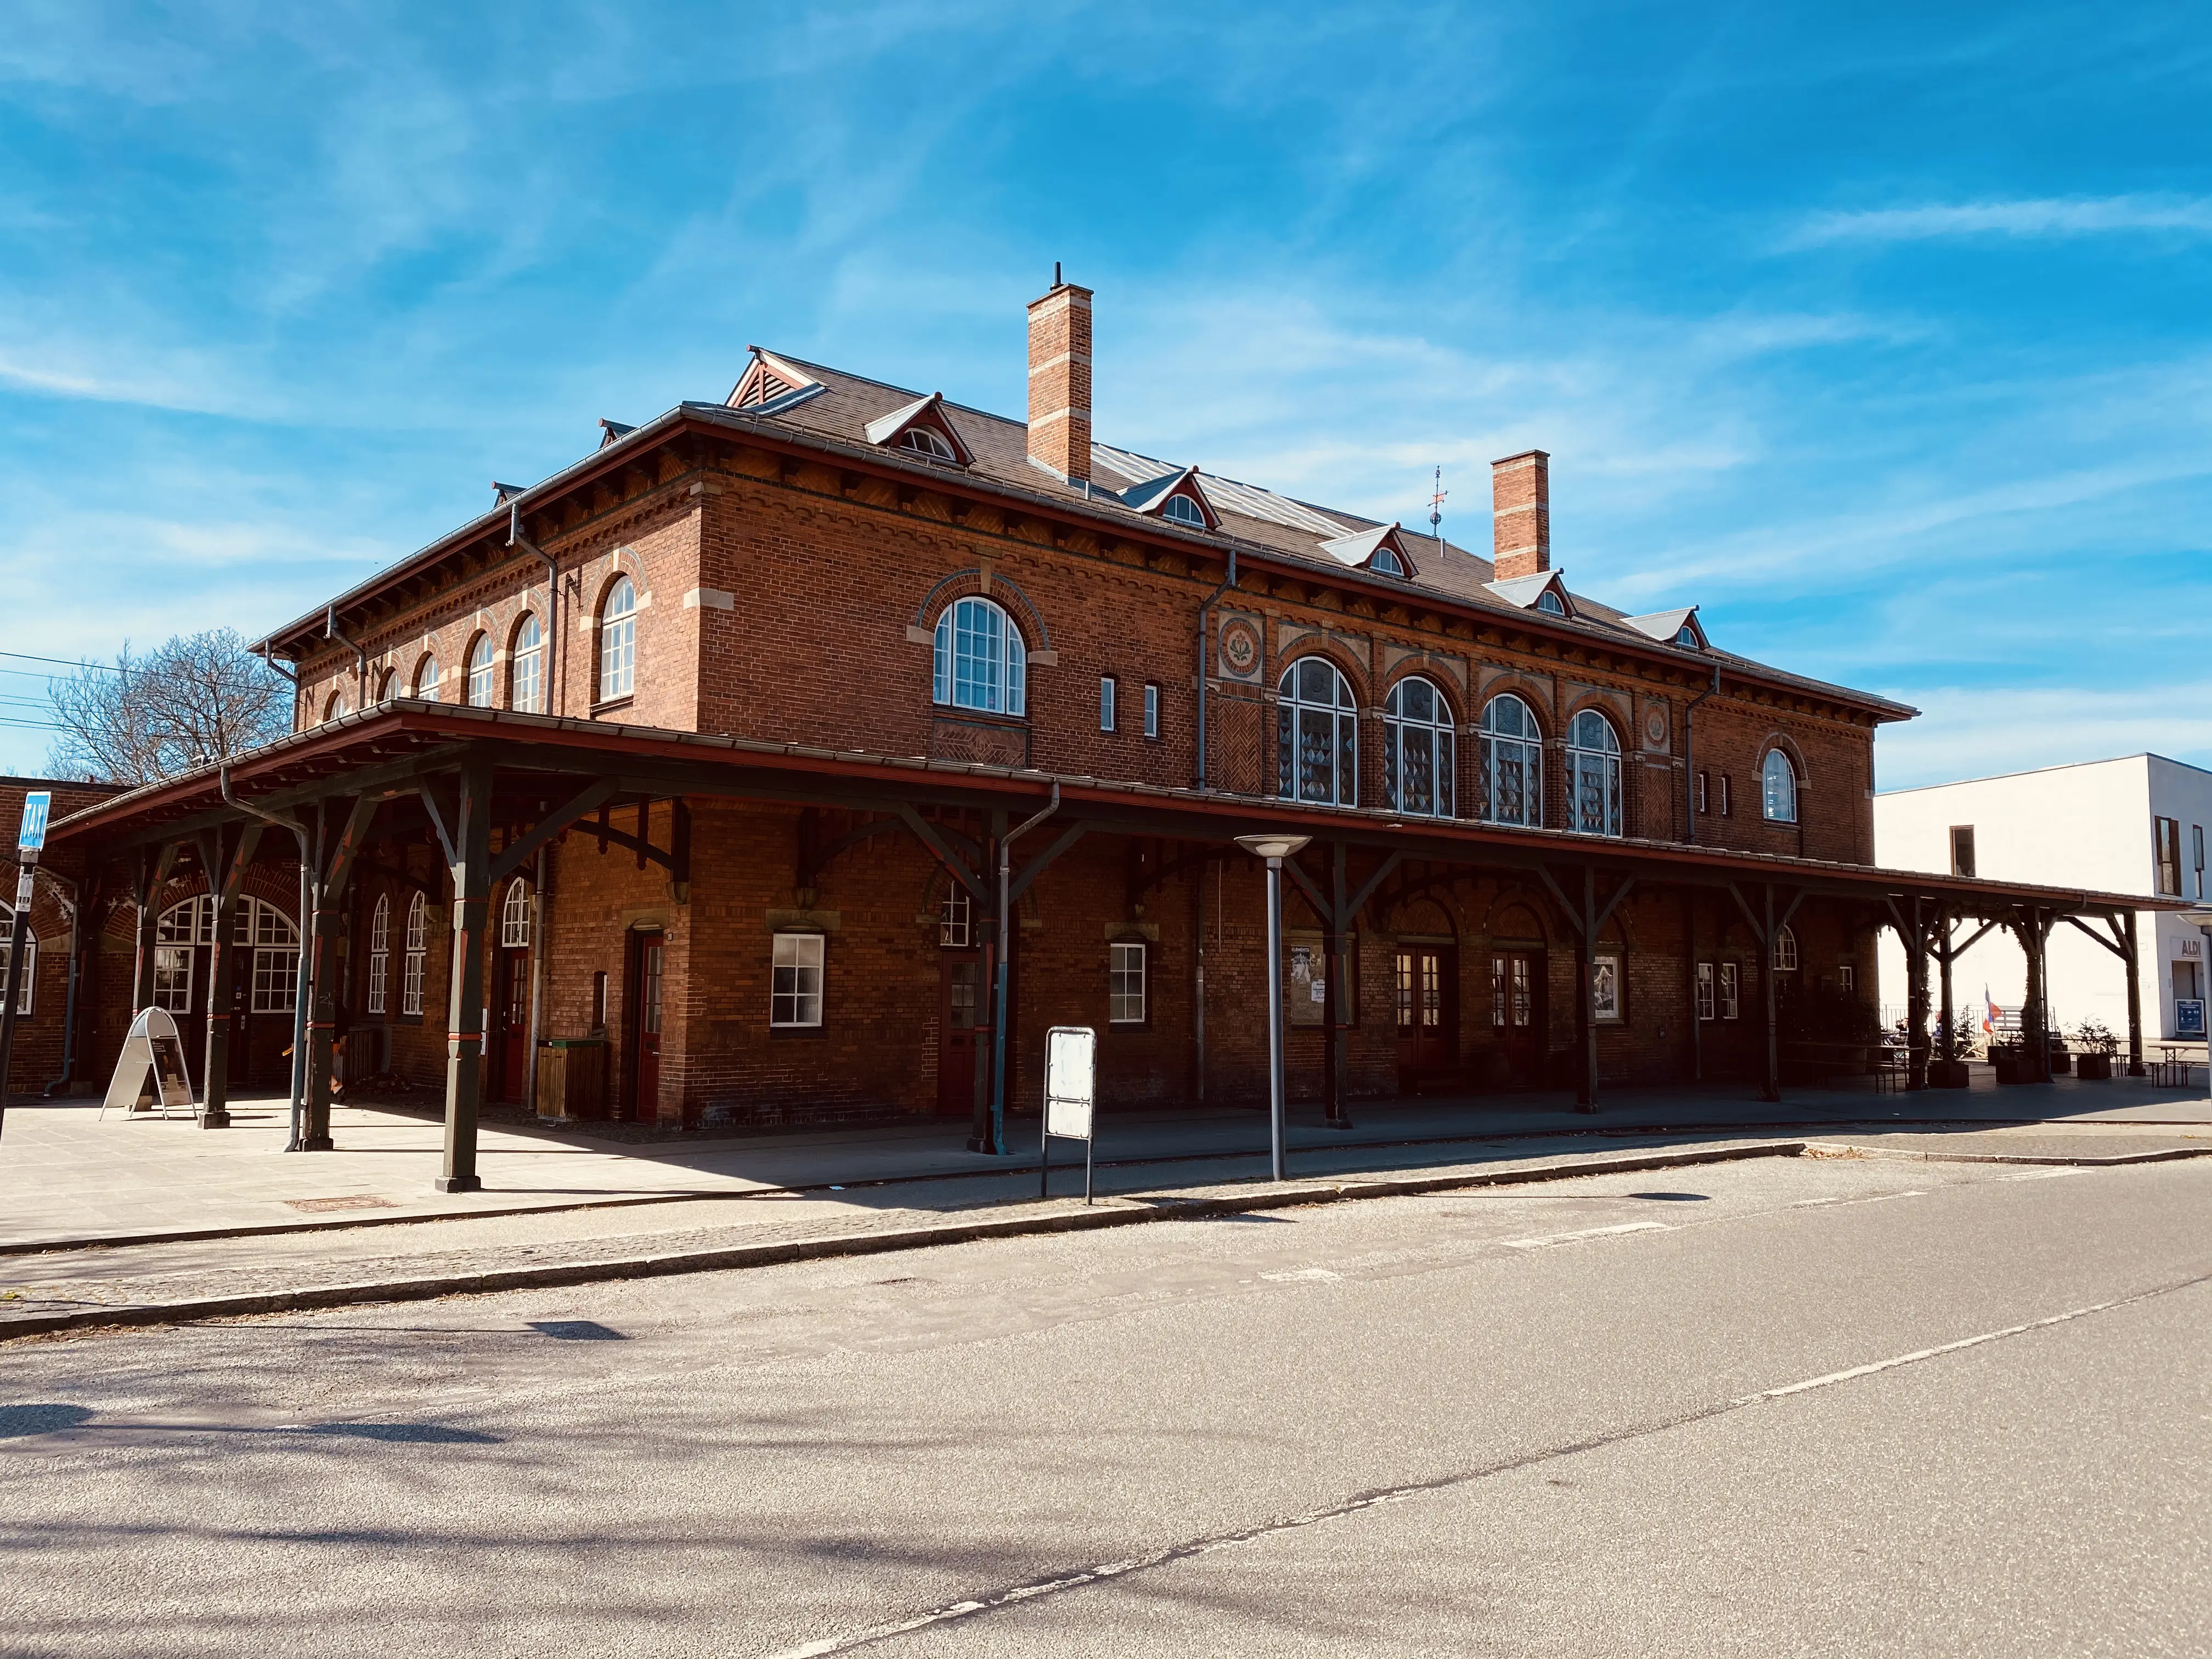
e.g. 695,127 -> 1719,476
1874,754 -> 2212,1042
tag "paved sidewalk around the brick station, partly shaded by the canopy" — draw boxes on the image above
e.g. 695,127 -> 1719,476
0,1068 -> 2212,1252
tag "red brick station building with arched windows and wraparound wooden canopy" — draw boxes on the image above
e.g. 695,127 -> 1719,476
0,283 -> 2143,1188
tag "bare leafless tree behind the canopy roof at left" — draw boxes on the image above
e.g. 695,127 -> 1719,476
47,628 -> 292,783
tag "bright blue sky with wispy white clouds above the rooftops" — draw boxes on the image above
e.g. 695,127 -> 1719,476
0,0 -> 2212,787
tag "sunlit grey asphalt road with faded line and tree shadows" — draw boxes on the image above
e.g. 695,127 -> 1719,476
0,1159 -> 2212,1655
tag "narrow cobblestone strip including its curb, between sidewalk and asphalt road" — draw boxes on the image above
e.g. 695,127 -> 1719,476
0,1142 -> 1805,1340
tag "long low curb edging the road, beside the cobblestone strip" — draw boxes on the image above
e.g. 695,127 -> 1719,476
0,1142 -> 1805,1342
